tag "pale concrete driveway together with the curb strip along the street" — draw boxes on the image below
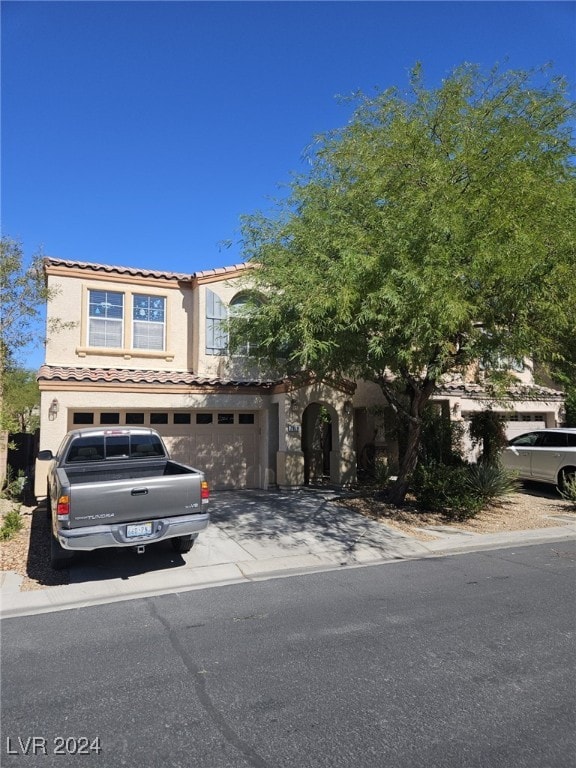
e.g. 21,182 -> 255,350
1,489 -> 574,616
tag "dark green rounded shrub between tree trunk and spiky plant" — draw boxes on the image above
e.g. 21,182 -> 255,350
412,461 -> 484,520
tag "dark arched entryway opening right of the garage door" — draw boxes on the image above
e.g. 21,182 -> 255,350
302,403 -> 338,485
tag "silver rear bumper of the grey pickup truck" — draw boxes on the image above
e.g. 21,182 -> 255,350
57,514 -> 210,551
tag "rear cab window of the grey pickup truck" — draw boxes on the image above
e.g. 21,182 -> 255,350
66,434 -> 165,463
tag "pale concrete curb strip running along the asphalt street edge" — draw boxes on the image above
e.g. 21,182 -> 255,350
0,524 -> 576,619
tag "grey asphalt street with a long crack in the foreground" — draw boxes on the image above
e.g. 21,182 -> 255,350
1,542 -> 576,768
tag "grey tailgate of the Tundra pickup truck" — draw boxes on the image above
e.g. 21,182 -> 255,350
64,474 -> 203,528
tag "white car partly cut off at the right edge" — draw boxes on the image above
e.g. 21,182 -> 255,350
502,427 -> 576,488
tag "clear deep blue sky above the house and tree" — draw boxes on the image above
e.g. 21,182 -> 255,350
1,0 -> 576,362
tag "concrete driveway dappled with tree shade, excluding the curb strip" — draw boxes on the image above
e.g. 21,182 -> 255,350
70,490 -> 428,584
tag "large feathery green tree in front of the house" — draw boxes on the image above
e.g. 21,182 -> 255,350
232,64 -> 576,503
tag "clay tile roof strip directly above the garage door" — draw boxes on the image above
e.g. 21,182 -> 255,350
37,365 -> 278,388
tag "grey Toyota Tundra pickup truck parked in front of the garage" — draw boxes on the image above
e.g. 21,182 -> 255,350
38,427 -> 209,569
